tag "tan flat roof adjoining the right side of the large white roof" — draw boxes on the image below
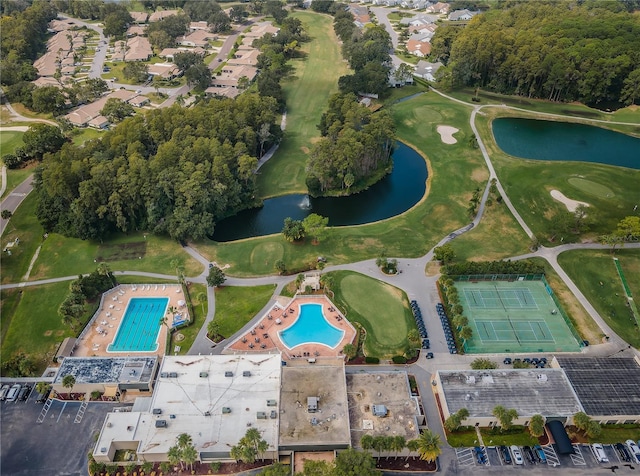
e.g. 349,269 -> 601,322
280,359 -> 350,448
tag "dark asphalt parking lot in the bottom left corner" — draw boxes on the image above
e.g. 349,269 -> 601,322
0,391 -> 114,476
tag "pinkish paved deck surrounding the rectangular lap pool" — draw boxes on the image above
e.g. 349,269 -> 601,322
72,284 -> 187,357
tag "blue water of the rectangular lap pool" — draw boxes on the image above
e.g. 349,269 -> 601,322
107,297 -> 169,352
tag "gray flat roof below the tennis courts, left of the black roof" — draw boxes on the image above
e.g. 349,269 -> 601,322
437,369 -> 582,418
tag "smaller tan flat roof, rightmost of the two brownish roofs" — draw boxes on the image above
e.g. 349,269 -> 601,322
347,372 -> 419,448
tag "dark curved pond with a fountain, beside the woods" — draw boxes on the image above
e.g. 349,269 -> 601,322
212,142 -> 427,242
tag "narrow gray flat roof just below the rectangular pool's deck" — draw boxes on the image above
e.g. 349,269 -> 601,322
53,356 -> 158,384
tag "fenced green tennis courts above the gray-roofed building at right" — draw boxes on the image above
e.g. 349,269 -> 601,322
455,280 -> 580,354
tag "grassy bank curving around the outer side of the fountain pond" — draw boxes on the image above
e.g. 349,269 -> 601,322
195,93 -> 488,276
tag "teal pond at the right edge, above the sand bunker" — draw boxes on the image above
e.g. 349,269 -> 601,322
492,118 -> 640,169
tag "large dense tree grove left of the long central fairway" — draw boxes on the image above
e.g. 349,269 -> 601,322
35,93 -> 282,240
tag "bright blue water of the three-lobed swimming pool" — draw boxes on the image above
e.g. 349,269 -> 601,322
279,304 -> 344,349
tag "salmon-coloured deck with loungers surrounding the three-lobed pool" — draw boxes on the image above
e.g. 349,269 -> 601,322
224,295 -> 356,360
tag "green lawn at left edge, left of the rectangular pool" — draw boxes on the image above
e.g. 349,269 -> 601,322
0,282 -> 75,371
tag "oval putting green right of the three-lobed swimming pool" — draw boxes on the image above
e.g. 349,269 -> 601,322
340,274 -> 409,347
